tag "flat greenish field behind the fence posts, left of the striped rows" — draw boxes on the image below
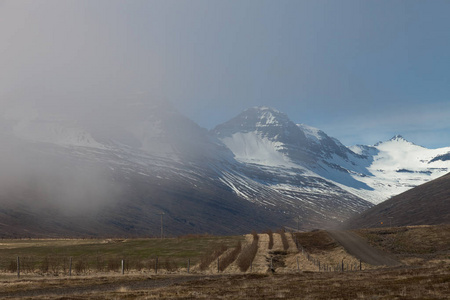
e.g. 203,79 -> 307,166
0,235 -> 245,275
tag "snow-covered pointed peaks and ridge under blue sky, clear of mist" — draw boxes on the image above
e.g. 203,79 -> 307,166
214,107 -> 450,203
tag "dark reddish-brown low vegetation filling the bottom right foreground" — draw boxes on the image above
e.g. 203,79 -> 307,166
144,268 -> 450,299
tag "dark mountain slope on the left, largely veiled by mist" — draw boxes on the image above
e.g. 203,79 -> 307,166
0,105 -> 280,236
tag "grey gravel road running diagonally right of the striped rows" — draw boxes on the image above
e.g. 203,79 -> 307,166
328,231 -> 400,266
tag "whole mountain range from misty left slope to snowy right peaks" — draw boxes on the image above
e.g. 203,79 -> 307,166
0,101 -> 450,236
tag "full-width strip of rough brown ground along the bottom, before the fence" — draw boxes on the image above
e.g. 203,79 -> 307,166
0,266 -> 450,299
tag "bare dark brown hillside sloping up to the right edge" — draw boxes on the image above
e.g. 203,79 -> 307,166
344,173 -> 450,228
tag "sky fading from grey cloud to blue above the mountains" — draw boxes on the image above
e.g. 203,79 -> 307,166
0,0 -> 450,148
